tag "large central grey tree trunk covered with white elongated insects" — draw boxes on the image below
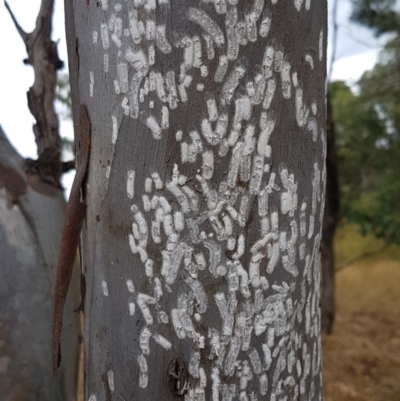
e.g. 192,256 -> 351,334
66,0 -> 326,401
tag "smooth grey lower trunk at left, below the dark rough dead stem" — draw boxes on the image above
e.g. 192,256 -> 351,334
0,128 -> 79,401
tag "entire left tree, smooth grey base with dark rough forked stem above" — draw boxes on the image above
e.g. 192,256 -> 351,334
0,0 -> 79,401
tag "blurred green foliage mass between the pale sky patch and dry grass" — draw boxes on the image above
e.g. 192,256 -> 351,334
330,39 -> 400,244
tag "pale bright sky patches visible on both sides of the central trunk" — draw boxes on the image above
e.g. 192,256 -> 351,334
0,0 -> 385,194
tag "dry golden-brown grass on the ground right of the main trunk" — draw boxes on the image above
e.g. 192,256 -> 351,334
323,228 -> 400,401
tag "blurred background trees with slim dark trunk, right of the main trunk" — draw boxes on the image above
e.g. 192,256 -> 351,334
321,0 -> 400,334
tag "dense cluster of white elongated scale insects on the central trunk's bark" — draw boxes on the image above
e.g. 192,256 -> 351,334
89,0 -> 326,401
